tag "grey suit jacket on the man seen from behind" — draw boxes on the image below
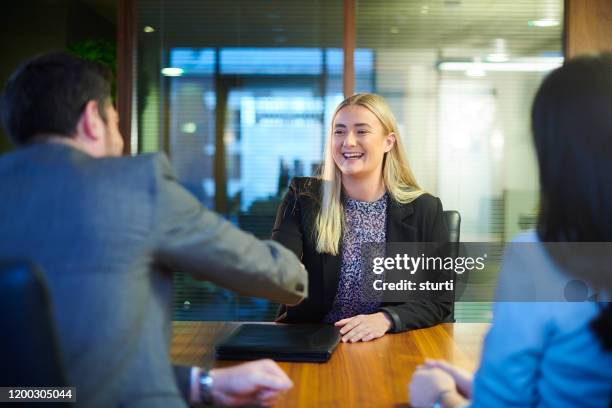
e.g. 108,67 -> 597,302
0,143 -> 307,407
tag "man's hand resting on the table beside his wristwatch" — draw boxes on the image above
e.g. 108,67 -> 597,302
210,360 -> 293,407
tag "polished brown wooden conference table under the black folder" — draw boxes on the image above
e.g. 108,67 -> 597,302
170,322 -> 489,408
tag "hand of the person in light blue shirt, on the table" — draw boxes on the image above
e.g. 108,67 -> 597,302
408,365 -> 456,408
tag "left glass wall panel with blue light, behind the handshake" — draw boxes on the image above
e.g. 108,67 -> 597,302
137,0 -> 346,320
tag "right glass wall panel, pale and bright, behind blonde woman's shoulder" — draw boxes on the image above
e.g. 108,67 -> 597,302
356,0 -> 563,321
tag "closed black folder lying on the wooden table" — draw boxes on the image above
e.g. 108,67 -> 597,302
217,323 -> 340,363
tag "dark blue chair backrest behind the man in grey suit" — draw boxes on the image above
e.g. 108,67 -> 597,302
0,262 -> 67,387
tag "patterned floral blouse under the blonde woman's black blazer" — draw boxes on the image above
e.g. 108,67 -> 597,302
324,193 -> 387,323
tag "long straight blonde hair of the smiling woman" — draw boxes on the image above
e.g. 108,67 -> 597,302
315,93 -> 425,255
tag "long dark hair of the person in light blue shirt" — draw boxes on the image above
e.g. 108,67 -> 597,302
531,54 -> 612,350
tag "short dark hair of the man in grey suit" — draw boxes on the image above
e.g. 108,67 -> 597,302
2,52 -> 112,145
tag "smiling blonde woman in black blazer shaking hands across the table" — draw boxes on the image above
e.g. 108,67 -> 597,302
272,94 -> 452,342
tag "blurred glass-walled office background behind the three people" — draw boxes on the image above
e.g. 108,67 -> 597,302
0,0 -> 612,322
